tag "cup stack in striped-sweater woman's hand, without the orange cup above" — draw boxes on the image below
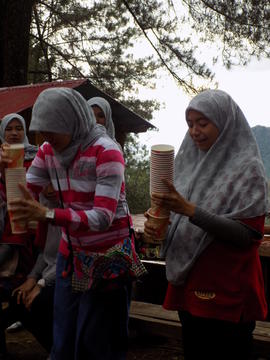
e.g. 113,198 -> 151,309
5,167 -> 27,234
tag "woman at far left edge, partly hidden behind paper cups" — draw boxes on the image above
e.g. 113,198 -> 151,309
0,113 -> 38,353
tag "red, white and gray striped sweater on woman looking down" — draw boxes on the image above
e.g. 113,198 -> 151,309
27,136 -> 132,255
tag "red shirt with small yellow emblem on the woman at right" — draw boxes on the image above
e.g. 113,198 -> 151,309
163,216 -> 267,322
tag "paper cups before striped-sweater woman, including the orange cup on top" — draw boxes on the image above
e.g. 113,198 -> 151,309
5,144 -> 27,234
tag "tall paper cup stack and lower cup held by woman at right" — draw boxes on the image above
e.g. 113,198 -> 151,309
144,144 -> 174,244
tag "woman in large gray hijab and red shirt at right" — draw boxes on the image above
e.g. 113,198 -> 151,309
145,90 -> 267,360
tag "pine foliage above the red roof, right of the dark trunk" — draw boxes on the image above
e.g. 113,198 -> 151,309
26,0 -> 212,100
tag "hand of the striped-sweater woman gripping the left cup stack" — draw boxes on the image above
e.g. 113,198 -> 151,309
8,184 -> 47,222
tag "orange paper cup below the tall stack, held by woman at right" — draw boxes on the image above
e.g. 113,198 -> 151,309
144,209 -> 169,244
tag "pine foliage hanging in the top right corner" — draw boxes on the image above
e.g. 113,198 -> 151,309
183,0 -> 270,68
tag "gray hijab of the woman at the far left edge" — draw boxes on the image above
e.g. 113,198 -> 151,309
0,113 -> 38,160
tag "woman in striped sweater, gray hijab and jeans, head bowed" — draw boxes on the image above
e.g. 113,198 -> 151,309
7,88 -> 143,360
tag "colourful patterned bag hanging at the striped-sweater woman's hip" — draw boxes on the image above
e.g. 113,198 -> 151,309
72,238 -> 146,292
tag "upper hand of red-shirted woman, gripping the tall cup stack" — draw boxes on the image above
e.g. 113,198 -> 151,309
151,179 -> 195,217
